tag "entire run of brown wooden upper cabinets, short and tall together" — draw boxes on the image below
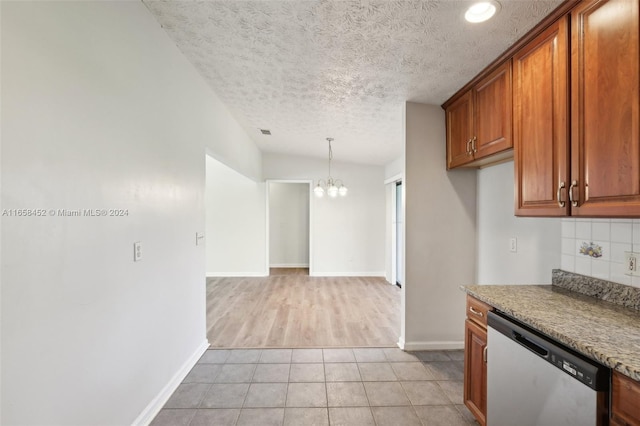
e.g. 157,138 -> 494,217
443,0 -> 640,217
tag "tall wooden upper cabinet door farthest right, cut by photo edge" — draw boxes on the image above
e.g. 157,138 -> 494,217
571,0 -> 640,216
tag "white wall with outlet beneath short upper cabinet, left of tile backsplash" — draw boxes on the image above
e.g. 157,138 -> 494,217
477,161 -> 560,284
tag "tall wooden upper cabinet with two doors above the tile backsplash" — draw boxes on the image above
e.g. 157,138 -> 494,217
513,0 -> 640,217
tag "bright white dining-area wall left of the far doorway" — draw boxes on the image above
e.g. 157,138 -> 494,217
205,156 -> 268,277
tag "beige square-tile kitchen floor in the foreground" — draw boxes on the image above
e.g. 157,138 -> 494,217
152,348 -> 476,426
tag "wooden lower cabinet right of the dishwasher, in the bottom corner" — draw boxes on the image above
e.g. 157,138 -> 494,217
611,371 -> 640,426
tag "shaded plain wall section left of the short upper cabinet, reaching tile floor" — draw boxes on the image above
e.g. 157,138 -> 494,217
399,102 -> 476,350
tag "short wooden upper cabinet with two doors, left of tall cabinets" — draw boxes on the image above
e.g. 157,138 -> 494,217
445,60 -> 513,169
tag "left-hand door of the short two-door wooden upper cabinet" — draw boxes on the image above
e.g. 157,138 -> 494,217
445,91 -> 473,169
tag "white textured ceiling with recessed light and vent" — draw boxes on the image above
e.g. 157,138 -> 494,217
144,0 -> 561,164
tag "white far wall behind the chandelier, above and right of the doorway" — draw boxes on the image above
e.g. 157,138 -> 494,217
262,153 -> 385,276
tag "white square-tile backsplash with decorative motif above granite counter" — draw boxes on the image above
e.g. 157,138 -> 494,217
560,218 -> 640,287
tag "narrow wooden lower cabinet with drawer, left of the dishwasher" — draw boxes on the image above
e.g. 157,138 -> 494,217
463,296 -> 492,426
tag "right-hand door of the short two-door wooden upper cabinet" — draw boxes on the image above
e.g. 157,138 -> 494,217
473,61 -> 513,159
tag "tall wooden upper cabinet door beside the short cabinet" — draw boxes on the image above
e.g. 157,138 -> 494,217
513,17 -> 569,216
